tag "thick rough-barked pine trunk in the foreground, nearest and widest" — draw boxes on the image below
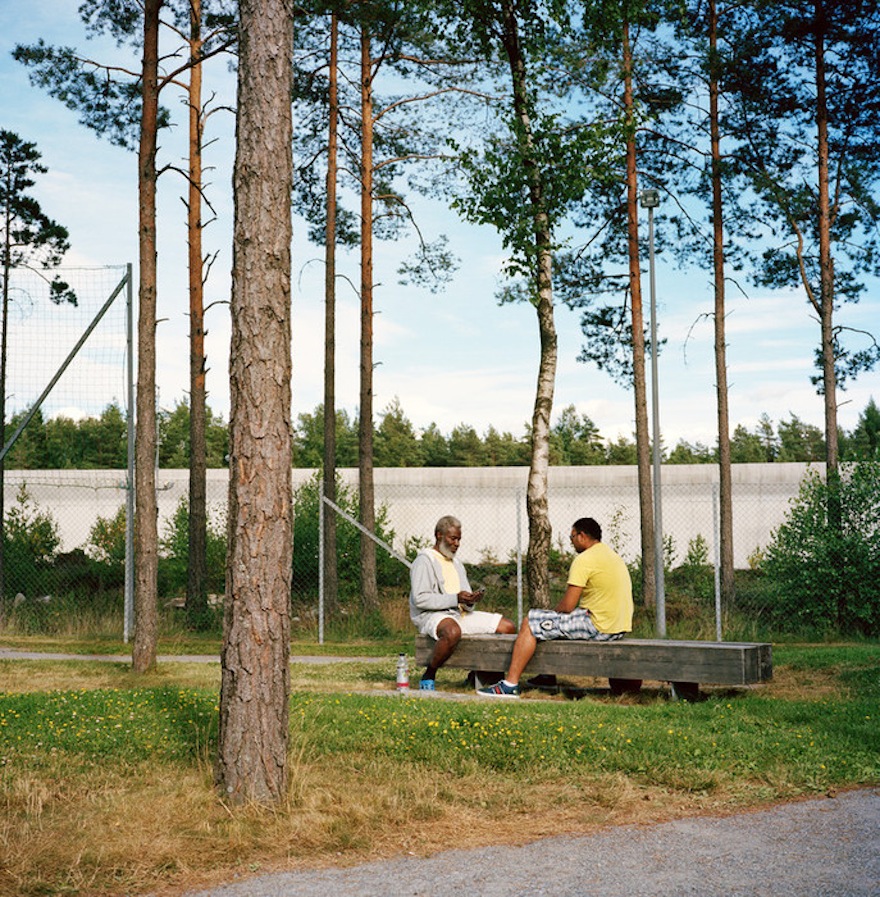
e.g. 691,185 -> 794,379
216,0 -> 293,803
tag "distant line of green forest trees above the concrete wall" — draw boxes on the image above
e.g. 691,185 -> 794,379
6,399 -> 880,470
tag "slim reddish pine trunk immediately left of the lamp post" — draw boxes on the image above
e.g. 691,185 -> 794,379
623,22 -> 656,607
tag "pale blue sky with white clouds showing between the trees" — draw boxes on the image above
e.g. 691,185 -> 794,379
0,0 -> 880,448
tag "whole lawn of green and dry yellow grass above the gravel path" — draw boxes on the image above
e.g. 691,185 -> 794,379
0,640 -> 880,897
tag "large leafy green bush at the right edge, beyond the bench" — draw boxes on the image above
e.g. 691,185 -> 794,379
761,461 -> 880,636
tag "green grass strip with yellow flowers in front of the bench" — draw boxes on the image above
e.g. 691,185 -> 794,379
292,695 -> 880,789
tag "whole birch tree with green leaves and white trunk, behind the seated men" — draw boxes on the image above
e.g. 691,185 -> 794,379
445,0 -> 592,607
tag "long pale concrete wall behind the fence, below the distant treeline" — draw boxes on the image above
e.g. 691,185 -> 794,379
5,464 -> 824,567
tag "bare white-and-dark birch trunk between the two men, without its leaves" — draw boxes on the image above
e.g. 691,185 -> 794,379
502,0 -> 557,607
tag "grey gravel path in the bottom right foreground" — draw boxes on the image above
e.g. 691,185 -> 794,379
187,789 -> 880,897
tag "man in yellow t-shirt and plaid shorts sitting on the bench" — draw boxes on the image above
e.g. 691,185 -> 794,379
477,517 -> 633,698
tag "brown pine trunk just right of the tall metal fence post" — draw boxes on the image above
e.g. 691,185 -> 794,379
132,0 -> 162,673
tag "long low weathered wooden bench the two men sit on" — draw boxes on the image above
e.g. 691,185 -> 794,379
416,635 -> 773,700
